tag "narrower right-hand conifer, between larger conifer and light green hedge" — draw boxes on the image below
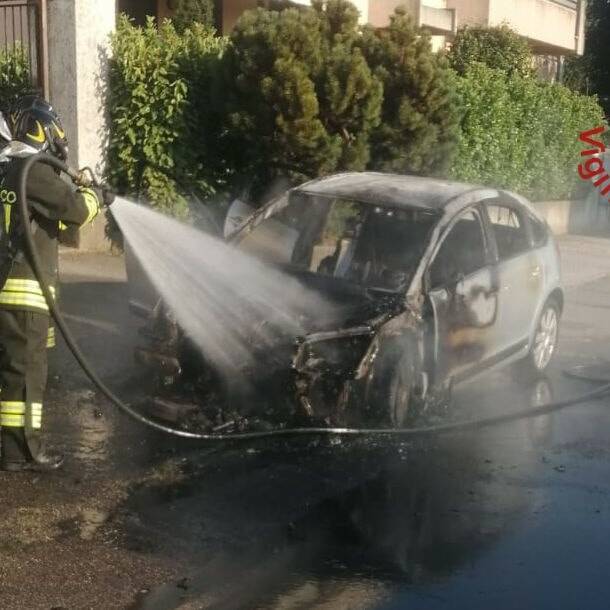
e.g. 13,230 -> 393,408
361,8 -> 460,174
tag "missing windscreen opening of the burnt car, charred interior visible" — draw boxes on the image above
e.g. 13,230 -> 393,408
238,193 -> 439,291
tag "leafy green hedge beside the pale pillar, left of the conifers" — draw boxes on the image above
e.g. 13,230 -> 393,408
107,17 -> 226,216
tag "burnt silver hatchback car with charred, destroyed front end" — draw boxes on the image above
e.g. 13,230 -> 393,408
128,173 -> 564,429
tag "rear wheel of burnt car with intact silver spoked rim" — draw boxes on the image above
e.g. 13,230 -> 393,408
515,297 -> 561,381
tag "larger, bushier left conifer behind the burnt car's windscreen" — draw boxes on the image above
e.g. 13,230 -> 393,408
227,0 -> 382,195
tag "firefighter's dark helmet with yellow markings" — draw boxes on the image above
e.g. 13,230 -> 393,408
10,95 -> 68,161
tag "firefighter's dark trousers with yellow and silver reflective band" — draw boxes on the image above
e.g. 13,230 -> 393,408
0,309 -> 49,462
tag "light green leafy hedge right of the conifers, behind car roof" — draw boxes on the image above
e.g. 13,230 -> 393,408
451,64 -> 603,200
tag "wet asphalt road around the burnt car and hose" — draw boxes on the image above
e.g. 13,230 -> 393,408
0,248 -> 610,610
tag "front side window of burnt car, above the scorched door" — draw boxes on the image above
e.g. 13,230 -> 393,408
429,211 -> 487,288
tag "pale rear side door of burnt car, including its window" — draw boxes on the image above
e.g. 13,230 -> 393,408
484,199 -> 544,356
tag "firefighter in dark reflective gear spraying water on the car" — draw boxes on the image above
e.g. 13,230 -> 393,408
0,96 -> 100,471
